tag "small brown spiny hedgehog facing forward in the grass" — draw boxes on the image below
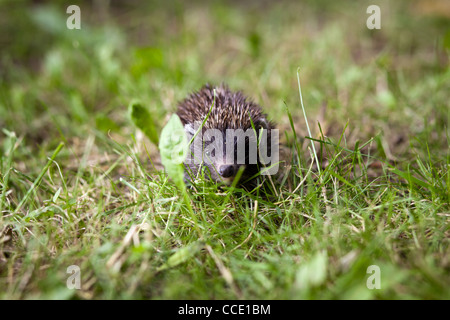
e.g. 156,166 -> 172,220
176,84 -> 278,187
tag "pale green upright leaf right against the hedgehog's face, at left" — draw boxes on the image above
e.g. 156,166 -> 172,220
159,114 -> 189,191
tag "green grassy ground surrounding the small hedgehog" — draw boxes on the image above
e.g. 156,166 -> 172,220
0,1 -> 450,299
